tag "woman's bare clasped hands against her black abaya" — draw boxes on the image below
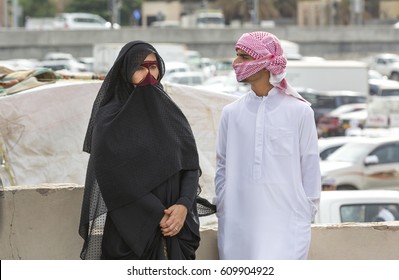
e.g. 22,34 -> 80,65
159,204 -> 187,237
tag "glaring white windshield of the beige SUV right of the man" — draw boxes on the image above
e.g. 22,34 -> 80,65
326,143 -> 373,163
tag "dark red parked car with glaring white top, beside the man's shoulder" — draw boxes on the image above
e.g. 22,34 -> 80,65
317,103 -> 367,137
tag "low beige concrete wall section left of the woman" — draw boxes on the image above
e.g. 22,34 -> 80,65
0,184 -> 83,260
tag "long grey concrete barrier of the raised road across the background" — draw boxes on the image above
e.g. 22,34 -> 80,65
0,25 -> 399,60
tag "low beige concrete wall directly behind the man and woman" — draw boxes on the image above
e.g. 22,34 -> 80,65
0,184 -> 399,260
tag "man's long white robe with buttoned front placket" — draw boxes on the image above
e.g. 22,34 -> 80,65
215,88 -> 321,259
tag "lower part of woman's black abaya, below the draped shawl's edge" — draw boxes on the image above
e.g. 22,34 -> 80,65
101,171 -> 200,260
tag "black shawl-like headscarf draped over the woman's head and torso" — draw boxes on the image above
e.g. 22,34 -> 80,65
80,41 -> 199,260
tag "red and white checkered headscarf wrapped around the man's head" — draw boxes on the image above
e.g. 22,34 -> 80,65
233,31 -> 309,103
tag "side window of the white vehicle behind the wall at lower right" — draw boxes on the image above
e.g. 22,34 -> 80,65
340,203 -> 399,223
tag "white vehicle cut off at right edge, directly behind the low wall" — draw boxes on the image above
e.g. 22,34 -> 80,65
314,190 -> 399,224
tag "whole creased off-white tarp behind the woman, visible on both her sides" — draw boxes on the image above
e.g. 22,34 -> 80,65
0,81 -> 237,205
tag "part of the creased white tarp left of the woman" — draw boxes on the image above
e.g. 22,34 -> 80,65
0,81 -> 101,186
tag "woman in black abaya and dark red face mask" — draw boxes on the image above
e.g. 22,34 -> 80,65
79,41 -> 200,259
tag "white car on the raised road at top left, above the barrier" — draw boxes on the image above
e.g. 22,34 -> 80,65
54,13 -> 120,29
